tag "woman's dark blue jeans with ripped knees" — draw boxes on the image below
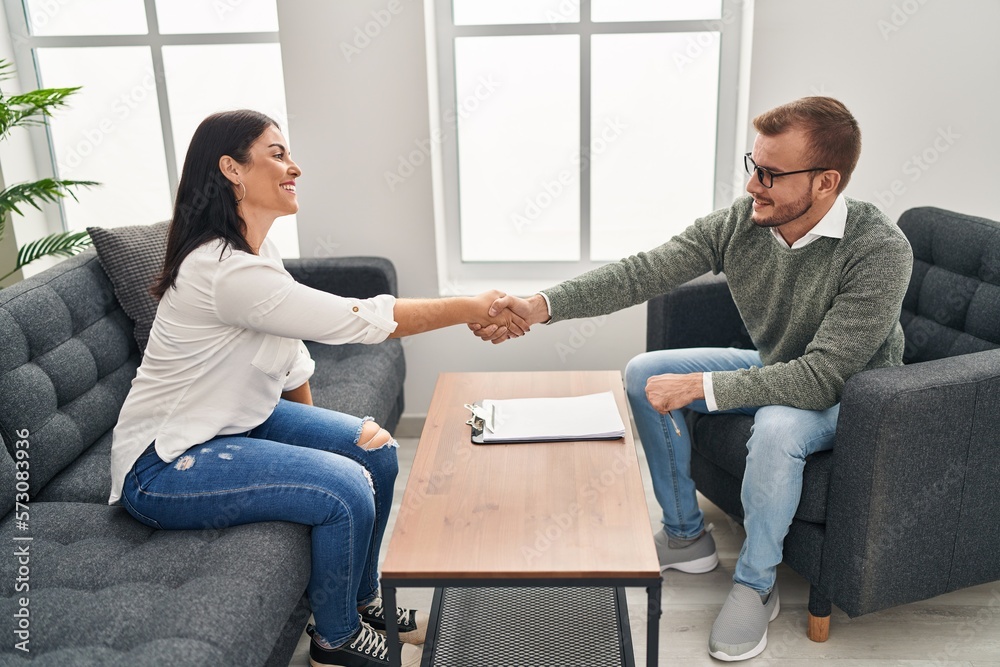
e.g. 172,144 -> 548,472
122,399 -> 399,646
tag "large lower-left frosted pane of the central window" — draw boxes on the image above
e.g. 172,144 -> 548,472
456,35 -> 580,261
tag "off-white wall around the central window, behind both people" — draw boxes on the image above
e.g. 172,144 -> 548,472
279,0 -> 1000,416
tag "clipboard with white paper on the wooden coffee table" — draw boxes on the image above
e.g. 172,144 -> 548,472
465,392 -> 625,445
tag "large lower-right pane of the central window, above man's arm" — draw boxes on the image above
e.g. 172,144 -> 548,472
590,32 -> 719,260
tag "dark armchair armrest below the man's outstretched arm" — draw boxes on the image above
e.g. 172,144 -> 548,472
646,273 -> 753,351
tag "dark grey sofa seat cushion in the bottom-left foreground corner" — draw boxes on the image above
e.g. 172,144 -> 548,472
0,502 -> 310,667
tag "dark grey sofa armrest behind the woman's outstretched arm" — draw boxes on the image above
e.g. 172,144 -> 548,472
282,257 -> 398,299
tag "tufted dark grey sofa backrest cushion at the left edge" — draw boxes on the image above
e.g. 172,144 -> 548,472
0,250 -> 138,496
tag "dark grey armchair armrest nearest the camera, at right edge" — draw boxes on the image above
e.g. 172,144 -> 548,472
820,350 -> 1000,616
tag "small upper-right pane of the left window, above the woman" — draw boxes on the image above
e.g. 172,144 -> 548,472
156,0 -> 278,35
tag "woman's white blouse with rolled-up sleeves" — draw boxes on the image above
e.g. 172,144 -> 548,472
108,240 -> 396,504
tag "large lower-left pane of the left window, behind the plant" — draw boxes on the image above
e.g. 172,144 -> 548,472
36,46 -> 171,230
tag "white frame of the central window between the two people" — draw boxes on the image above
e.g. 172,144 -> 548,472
426,0 -> 752,294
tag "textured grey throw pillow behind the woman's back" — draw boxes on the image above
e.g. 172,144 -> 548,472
87,221 -> 170,354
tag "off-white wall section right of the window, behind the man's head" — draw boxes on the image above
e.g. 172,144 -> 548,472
748,0 -> 1000,220
